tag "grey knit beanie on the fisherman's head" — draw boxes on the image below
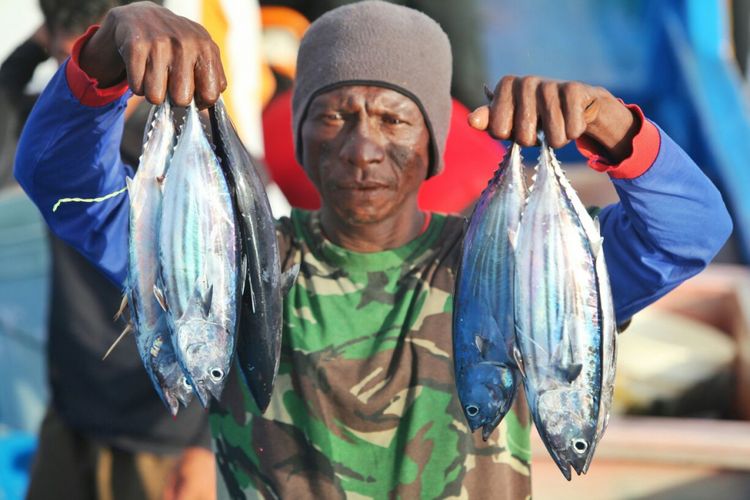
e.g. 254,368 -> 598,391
292,0 -> 451,177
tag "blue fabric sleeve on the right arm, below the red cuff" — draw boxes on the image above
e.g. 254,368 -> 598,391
599,123 -> 732,324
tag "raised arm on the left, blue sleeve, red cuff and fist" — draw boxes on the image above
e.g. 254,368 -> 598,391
15,2 -> 226,285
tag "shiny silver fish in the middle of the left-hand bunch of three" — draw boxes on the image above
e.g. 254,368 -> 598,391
153,102 -> 241,407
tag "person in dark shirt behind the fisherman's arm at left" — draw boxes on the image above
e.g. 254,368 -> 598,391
0,0 -> 215,500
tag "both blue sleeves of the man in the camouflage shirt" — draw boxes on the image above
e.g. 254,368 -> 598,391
15,63 -> 732,321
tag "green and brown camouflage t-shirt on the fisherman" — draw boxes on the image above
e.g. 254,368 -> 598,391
210,211 -> 530,499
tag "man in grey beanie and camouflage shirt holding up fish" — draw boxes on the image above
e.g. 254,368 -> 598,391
16,1 -> 731,498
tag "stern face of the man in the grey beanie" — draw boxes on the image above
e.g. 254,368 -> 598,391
302,85 -> 430,225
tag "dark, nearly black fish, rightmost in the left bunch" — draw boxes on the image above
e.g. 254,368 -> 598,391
209,99 -> 299,413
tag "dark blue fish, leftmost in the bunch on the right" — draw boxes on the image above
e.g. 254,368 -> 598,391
453,143 -> 528,441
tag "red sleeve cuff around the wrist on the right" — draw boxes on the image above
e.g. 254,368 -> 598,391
576,104 -> 661,179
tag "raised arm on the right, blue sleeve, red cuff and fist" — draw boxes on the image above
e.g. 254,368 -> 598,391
469,77 -> 732,323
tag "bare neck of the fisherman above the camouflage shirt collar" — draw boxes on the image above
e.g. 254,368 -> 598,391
320,203 -> 425,253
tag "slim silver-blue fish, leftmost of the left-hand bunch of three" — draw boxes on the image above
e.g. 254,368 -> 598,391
114,100 -> 193,416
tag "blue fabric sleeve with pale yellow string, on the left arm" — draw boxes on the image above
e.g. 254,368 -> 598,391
15,63 -> 133,286
